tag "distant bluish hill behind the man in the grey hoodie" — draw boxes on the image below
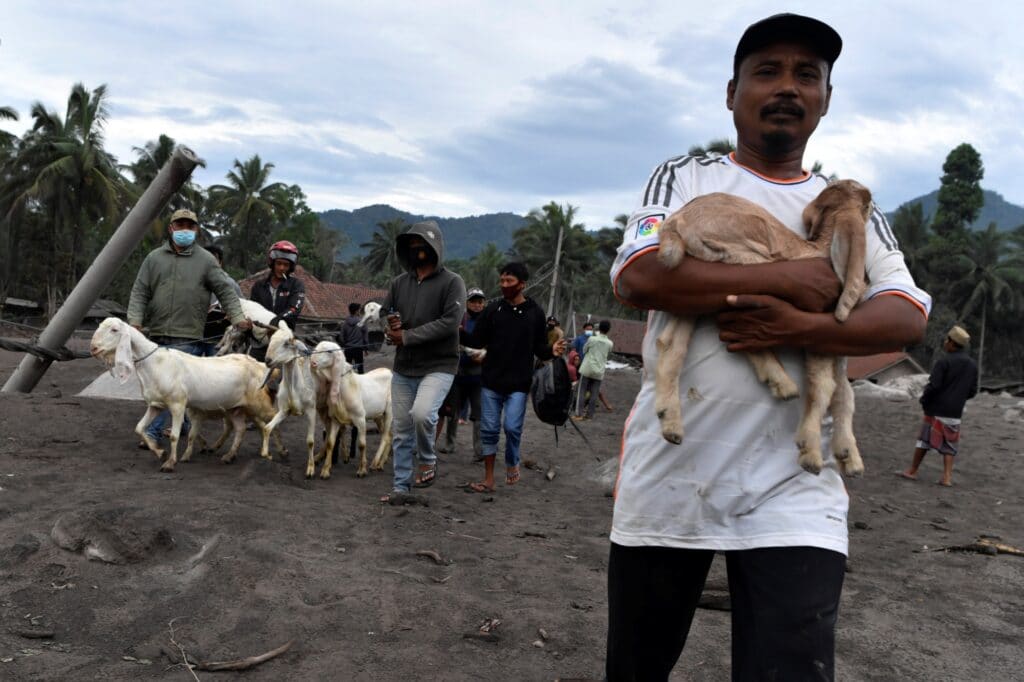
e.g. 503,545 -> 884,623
319,204 -> 525,260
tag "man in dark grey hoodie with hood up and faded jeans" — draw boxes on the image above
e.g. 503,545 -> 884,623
381,220 -> 466,503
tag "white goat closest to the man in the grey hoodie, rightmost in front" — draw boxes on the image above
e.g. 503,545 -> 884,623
306,341 -> 392,478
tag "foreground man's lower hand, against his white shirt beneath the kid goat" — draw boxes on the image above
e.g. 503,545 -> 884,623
715,295 -> 812,352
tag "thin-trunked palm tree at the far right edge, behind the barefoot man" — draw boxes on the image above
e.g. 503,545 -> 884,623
951,222 -> 1024,387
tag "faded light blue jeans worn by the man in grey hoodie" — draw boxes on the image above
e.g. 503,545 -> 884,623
391,372 -> 455,493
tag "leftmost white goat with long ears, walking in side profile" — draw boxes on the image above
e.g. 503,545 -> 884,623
89,317 -> 276,471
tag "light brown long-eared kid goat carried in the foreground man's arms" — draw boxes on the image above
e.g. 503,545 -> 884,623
654,180 -> 871,476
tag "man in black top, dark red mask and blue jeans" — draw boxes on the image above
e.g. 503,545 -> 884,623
463,262 -> 565,493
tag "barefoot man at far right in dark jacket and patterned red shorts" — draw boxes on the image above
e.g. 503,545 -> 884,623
900,325 -> 978,487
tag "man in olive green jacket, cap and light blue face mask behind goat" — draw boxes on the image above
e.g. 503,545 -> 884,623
128,209 -> 252,440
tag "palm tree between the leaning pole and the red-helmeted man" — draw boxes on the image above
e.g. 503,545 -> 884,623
209,154 -> 288,273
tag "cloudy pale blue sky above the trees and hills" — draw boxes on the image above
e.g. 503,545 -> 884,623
0,0 -> 1024,228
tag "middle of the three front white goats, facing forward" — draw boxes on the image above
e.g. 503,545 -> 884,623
258,322 -> 317,464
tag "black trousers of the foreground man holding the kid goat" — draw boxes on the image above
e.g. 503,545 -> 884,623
606,543 -> 846,682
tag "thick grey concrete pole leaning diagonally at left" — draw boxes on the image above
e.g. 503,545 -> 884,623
0,147 -> 199,393
